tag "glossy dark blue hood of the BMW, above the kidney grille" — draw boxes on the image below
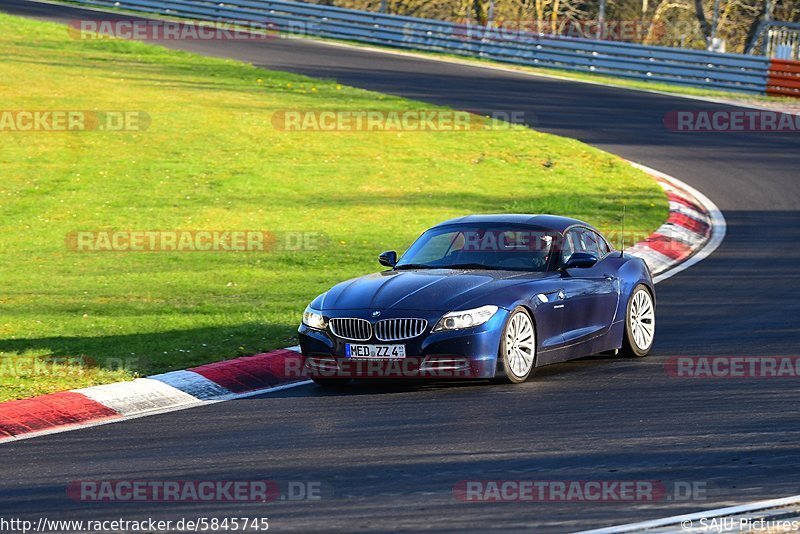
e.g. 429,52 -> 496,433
317,269 -> 552,312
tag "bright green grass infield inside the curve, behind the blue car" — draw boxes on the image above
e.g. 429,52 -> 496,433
0,15 -> 667,400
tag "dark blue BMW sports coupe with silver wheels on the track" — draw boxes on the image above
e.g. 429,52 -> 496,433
299,215 -> 655,385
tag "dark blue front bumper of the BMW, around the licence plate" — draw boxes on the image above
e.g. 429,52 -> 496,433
298,308 -> 508,379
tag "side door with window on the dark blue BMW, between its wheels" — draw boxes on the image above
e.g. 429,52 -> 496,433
561,227 -> 619,344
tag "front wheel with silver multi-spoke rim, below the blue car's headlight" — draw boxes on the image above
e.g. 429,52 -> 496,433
498,306 -> 536,384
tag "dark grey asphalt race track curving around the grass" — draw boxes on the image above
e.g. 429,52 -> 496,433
0,0 -> 800,532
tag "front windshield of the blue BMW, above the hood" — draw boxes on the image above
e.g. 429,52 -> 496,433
395,226 -> 555,271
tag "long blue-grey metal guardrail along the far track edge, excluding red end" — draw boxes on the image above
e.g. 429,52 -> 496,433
73,0 -> 769,93
